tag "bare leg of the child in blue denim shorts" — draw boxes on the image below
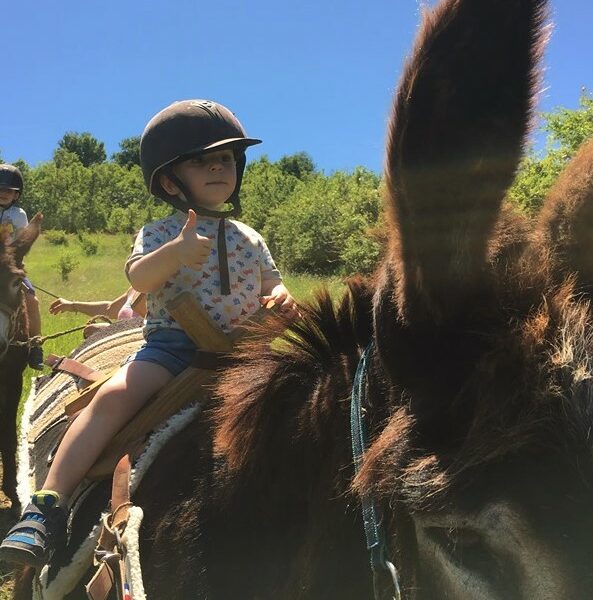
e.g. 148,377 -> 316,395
43,361 -> 173,497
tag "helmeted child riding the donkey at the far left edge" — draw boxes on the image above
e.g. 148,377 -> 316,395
0,164 -> 43,371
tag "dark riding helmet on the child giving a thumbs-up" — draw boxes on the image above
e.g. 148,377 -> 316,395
140,100 -> 261,214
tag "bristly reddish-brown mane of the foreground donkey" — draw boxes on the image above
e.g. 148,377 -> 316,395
215,278 -> 372,478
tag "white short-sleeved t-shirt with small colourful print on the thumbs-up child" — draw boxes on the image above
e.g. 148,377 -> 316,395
126,211 -> 280,337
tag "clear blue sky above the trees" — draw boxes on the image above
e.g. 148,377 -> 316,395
0,0 -> 593,172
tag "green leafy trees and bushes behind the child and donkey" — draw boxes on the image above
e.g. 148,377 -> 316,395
0,92 -> 593,275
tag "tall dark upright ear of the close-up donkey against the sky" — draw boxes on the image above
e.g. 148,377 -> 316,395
386,0 -> 547,322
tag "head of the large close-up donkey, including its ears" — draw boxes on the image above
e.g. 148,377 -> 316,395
357,0 -> 593,600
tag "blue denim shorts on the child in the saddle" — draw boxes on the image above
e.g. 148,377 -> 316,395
124,329 -> 197,376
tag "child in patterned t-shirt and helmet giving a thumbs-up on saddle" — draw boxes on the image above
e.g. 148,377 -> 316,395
0,100 -> 298,566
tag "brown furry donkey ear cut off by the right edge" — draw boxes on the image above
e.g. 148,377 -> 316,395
531,139 -> 593,294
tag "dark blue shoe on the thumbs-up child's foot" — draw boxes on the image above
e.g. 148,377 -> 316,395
0,504 -> 66,567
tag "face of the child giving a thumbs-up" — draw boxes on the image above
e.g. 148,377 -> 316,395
173,148 -> 237,209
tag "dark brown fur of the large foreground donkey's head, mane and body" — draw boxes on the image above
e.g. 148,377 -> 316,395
13,0 -> 593,600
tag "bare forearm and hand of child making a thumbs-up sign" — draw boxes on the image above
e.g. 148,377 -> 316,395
128,210 -> 212,293
